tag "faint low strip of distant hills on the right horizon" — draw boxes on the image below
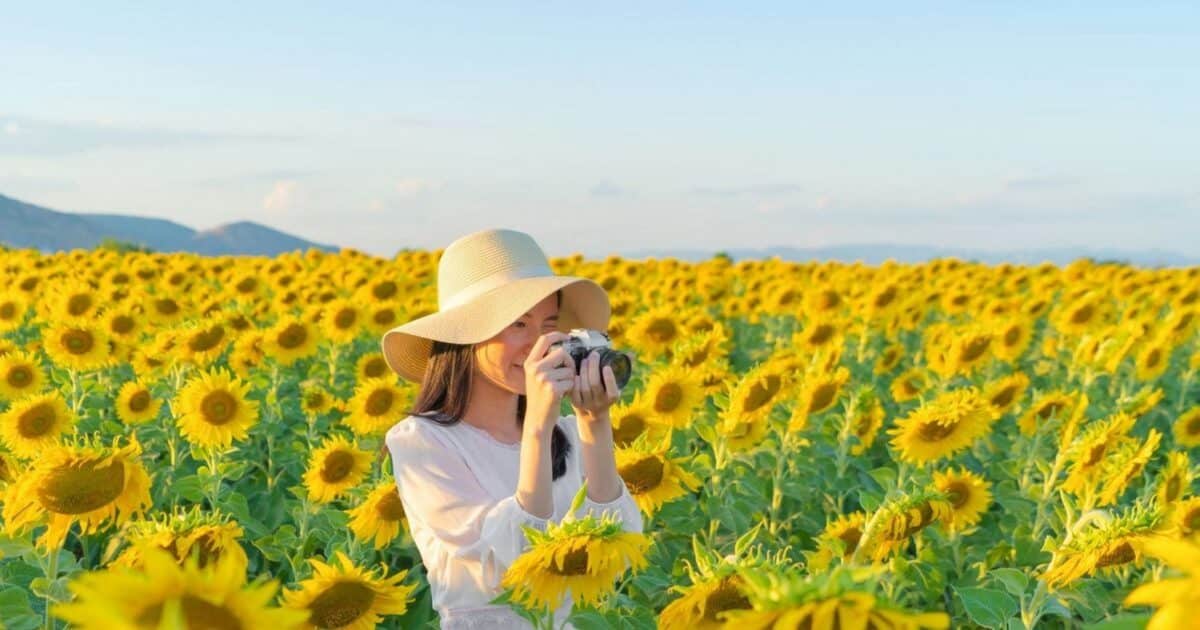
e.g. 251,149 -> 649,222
623,242 -> 1200,268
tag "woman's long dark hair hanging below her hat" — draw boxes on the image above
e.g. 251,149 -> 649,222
408,290 -> 571,480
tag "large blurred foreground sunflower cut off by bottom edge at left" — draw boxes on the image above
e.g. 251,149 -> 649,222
50,545 -> 305,630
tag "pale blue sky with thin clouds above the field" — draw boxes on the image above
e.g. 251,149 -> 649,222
0,1 -> 1200,257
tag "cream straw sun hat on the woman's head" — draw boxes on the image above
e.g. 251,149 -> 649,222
383,229 -> 612,383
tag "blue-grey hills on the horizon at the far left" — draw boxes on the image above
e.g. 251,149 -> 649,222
0,194 -> 338,256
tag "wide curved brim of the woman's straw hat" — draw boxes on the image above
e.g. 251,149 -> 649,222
382,275 -> 612,383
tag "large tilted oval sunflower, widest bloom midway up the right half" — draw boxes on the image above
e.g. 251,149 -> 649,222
888,388 -> 992,464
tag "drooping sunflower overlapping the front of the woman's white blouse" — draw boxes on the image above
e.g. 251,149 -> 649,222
500,501 -> 650,610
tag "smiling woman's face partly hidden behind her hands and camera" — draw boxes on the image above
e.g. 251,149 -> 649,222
475,294 -> 558,394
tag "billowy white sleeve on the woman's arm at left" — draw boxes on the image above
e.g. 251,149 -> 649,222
388,418 -> 547,589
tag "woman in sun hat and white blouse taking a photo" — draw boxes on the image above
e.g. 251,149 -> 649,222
383,229 -> 642,630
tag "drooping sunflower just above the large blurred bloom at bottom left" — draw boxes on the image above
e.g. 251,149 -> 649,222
112,506 -> 248,575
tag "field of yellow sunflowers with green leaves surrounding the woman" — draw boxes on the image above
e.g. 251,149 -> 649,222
0,248 -> 1200,630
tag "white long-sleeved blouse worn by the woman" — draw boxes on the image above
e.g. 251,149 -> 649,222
386,414 -> 643,630
